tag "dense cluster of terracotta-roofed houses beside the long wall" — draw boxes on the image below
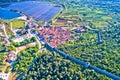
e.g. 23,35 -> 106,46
39,27 -> 70,47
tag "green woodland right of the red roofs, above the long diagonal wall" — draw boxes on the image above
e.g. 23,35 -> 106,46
59,25 -> 120,75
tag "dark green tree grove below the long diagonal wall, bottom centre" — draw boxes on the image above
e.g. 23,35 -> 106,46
22,53 -> 108,80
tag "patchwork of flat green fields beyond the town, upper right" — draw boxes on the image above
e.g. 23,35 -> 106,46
52,0 -> 119,29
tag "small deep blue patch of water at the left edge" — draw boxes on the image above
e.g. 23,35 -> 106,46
0,8 -> 21,20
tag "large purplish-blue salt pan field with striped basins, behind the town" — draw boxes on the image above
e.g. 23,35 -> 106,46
5,1 -> 61,21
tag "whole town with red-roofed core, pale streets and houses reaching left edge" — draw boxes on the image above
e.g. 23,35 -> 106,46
0,12 -> 87,80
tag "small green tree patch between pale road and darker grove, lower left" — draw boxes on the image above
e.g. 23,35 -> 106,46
13,45 -> 38,73
